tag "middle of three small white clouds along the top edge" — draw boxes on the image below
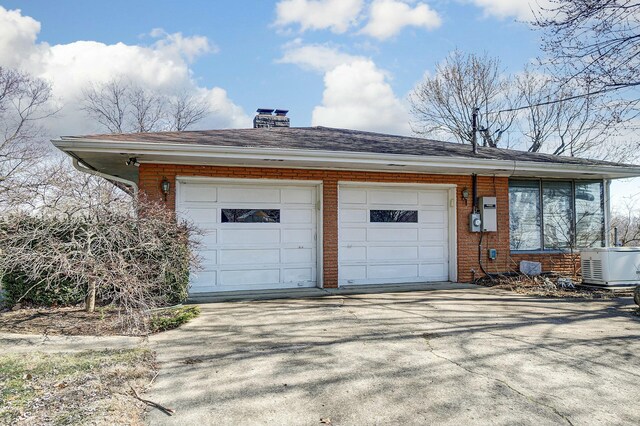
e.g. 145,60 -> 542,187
360,0 -> 442,40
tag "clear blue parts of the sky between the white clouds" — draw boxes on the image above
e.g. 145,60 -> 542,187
0,0 -> 538,133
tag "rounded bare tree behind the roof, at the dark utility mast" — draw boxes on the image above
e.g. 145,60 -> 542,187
409,50 -> 515,147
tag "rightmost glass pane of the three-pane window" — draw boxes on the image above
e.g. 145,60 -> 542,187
576,182 -> 604,247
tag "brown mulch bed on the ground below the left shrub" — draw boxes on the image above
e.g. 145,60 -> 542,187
0,306 -> 129,336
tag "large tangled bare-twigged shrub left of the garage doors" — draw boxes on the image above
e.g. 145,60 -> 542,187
0,203 -> 195,328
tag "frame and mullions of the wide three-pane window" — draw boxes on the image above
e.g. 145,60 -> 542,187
508,178 -> 608,254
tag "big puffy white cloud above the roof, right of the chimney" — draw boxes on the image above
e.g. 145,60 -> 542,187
311,59 -> 410,134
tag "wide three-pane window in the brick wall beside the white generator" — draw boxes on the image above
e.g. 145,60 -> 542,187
509,180 -> 604,251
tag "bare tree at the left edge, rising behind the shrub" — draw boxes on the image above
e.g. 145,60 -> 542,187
0,67 -> 56,208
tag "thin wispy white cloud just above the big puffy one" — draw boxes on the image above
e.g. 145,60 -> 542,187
277,39 -> 363,73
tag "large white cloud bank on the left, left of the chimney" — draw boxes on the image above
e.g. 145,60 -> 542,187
0,6 -> 251,136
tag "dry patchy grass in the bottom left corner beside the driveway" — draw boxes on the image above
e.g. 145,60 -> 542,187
0,349 -> 155,425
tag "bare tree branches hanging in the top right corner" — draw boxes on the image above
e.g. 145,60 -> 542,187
533,0 -> 640,94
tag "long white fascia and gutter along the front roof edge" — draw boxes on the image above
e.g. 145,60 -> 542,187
51,139 -> 640,178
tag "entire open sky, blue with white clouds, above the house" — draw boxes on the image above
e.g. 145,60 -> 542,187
0,0 -> 638,205
